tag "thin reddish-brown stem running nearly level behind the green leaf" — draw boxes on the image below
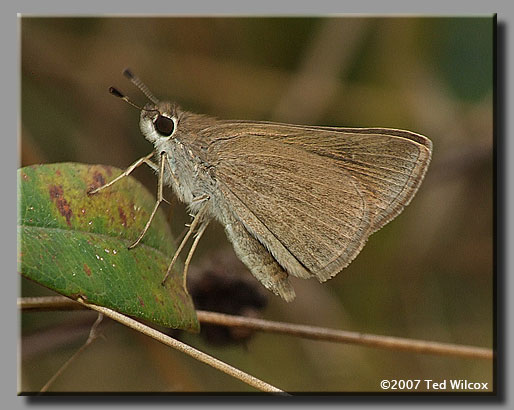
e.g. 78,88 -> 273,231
18,296 -> 494,360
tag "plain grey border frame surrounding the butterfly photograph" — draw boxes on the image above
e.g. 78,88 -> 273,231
8,0 -> 508,409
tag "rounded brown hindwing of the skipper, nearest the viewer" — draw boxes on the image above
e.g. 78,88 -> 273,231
209,135 -> 372,280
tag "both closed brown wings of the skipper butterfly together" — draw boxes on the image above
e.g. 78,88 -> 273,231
209,122 -> 431,281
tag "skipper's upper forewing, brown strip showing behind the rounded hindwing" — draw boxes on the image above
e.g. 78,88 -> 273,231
210,121 -> 432,232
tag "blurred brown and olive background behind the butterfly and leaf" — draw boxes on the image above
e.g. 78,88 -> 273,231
19,17 -> 494,392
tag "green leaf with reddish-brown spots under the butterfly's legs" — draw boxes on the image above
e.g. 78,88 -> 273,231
18,163 -> 199,331
